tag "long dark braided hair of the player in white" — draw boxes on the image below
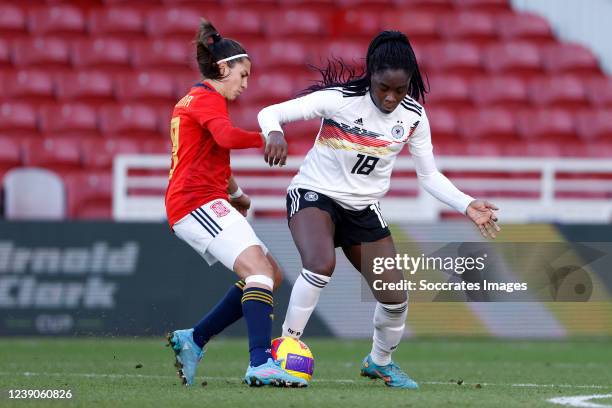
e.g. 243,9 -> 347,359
301,31 -> 427,102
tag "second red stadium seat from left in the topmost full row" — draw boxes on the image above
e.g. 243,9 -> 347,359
28,5 -> 85,35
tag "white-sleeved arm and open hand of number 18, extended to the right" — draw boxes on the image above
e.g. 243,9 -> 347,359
408,113 -> 500,238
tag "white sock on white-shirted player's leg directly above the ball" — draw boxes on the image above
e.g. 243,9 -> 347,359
283,269 -> 331,339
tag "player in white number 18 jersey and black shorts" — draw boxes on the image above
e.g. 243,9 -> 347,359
258,31 -> 499,388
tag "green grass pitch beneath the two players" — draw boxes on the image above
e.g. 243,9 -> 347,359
0,338 -> 612,408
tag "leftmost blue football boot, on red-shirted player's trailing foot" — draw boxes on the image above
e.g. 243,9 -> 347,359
168,329 -> 204,385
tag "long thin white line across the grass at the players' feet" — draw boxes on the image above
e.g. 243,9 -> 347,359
0,371 -> 612,389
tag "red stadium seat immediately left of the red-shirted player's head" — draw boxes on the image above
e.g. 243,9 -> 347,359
132,40 -> 195,73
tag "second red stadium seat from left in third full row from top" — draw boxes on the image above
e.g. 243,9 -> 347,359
57,71 -> 115,104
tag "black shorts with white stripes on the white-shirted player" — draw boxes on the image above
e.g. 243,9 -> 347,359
287,188 -> 391,248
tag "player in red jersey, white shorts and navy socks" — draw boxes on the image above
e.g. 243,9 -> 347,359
166,20 -> 307,386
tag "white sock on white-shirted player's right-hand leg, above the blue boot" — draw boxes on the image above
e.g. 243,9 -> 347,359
370,302 -> 408,366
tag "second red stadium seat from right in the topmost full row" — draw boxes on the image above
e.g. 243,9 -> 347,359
438,12 -> 497,45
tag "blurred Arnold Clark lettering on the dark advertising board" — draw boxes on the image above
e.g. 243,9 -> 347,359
0,241 -> 139,309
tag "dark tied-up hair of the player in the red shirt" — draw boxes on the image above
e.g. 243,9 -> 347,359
195,19 -> 248,79
